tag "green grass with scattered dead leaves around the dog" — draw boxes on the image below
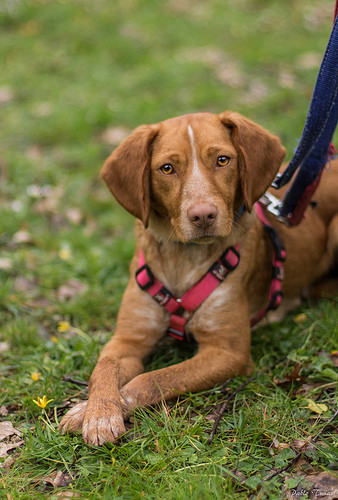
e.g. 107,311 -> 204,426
0,0 -> 337,500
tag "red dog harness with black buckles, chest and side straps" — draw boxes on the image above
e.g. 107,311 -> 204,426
135,203 -> 285,340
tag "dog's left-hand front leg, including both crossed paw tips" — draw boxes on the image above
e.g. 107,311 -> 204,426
60,284 -> 166,445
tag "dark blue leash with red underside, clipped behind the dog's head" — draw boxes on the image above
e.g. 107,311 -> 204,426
267,13 -> 338,226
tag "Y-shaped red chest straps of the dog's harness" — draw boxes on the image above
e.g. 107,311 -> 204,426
135,245 -> 240,340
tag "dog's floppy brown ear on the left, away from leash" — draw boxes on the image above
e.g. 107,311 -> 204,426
101,125 -> 158,227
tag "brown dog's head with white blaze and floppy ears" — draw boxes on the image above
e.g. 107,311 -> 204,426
101,111 -> 285,243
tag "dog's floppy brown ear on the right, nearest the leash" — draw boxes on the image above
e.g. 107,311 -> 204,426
220,111 -> 285,212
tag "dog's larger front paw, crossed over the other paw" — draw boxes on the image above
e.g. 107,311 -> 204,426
82,400 -> 126,446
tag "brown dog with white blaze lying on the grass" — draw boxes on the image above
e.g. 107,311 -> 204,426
60,112 -> 338,444
